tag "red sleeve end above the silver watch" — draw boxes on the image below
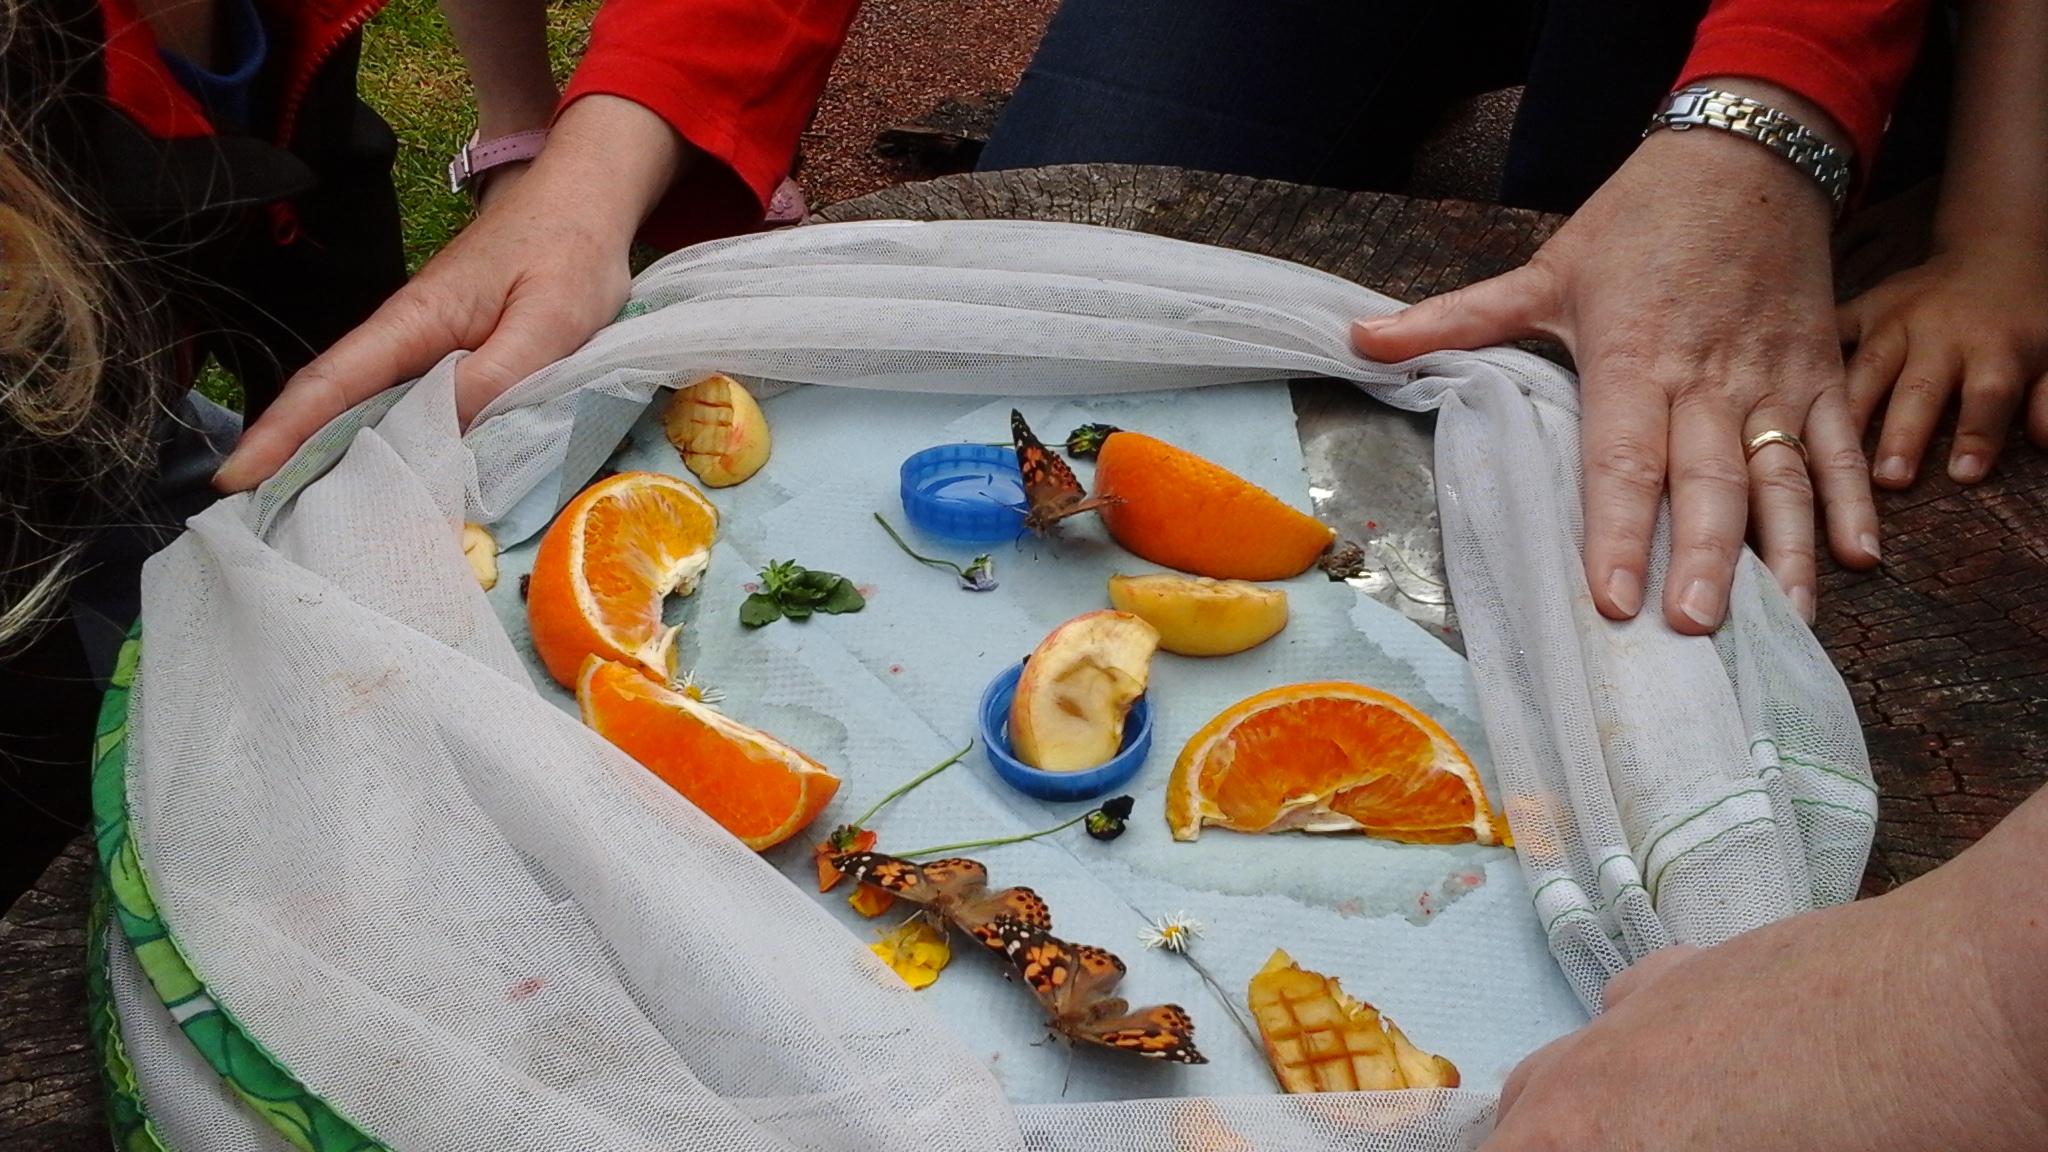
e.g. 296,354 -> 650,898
1677,0 -> 1929,176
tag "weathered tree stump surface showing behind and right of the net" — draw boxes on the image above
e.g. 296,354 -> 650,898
819,164 -> 2048,894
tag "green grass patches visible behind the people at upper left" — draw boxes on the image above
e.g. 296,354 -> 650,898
197,0 -> 598,410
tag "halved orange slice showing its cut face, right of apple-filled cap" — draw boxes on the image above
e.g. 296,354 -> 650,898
1171,680 -> 1507,845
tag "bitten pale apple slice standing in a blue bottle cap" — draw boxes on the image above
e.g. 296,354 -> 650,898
1010,609 -> 1159,773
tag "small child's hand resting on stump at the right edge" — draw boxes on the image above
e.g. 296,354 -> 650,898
1837,244 -> 2048,488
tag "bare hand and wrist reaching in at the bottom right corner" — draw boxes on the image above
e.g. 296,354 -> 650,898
1481,778 -> 2048,1152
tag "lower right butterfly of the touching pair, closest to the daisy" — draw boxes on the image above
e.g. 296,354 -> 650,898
993,916 -> 1208,1064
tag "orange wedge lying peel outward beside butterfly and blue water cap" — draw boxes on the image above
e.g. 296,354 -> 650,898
1096,433 -> 1337,580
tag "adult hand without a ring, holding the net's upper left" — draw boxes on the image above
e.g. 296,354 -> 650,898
213,96 -> 688,492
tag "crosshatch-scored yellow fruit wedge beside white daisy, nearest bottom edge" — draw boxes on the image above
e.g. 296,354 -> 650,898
1247,949 -> 1458,1093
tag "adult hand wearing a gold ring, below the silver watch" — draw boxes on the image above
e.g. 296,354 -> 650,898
1354,80 -> 1878,633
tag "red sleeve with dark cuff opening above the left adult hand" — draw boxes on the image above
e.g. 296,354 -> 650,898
563,0 -> 860,248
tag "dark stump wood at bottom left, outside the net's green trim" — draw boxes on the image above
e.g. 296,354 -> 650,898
0,836 -> 109,1152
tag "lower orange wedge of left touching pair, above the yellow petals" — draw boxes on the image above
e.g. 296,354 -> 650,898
575,656 -> 840,853
